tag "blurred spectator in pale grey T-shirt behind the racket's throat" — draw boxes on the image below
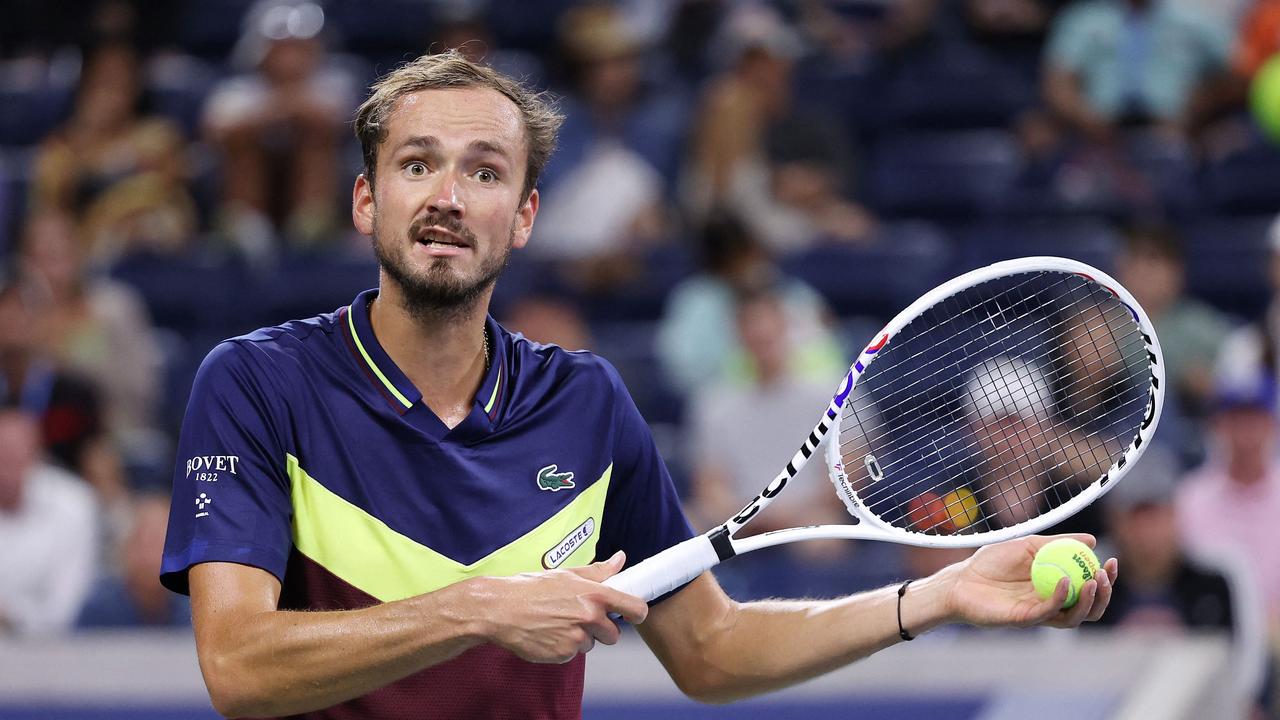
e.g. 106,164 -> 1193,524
687,282 -> 850,594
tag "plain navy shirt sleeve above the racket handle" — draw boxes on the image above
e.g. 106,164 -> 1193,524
596,358 -> 694,599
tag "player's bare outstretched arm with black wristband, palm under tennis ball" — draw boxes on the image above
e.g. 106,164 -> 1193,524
637,536 -> 1117,703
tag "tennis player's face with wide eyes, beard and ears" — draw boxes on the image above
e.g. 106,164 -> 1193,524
352,88 -> 538,313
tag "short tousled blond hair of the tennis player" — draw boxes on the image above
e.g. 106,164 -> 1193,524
356,50 -> 564,202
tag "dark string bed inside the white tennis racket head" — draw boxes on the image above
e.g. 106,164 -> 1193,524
840,273 -> 1147,533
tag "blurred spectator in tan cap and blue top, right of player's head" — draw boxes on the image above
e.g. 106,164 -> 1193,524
536,4 -> 685,273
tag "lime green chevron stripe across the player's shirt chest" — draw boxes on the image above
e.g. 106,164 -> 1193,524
287,455 -> 613,602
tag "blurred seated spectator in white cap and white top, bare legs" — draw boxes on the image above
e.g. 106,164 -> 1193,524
204,0 -> 356,260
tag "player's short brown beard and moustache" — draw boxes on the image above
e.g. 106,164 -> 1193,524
371,213 -> 516,319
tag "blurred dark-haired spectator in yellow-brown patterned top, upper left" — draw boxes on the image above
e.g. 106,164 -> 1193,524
32,41 -> 196,263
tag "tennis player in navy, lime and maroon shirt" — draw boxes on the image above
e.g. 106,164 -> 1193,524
163,53 -> 1116,717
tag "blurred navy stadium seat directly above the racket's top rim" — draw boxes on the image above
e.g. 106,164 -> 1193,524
956,217 -> 1120,272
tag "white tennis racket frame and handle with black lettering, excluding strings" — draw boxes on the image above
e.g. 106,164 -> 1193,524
604,256 -> 1165,601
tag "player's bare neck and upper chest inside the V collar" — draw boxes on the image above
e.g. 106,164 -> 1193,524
373,275 -> 492,428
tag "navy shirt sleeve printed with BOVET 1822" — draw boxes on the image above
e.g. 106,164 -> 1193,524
160,341 -> 292,594
